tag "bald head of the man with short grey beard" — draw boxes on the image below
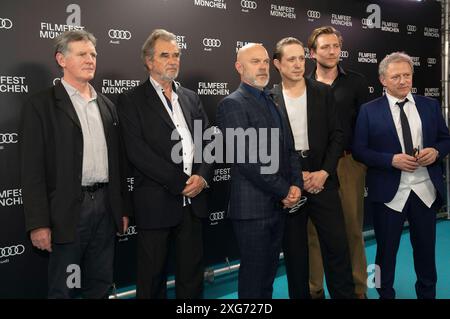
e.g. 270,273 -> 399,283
235,43 -> 270,90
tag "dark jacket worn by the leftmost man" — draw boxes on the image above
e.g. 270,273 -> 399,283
20,83 -> 130,243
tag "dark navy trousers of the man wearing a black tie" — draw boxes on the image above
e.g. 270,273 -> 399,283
373,191 -> 441,299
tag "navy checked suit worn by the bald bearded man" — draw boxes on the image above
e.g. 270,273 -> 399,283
217,84 -> 302,298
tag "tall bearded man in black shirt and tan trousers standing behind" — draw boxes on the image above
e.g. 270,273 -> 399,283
308,26 -> 368,298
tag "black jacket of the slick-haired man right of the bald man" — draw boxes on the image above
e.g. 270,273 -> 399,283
272,78 -> 344,188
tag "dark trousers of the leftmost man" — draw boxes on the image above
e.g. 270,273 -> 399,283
48,186 -> 115,299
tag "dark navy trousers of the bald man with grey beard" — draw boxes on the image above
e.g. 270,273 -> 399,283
232,209 -> 285,299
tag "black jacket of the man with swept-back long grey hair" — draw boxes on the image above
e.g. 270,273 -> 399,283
118,80 -> 212,229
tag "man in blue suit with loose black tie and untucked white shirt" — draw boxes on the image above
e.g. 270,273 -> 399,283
353,52 -> 450,299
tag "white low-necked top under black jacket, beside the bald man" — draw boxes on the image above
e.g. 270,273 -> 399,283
283,89 -> 309,151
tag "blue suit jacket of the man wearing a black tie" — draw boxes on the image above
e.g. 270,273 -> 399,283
353,95 -> 450,203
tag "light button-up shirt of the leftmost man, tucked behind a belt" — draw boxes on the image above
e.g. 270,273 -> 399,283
61,79 -> 108,186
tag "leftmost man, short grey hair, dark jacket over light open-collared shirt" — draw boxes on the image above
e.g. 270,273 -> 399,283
20,30 -> 130,298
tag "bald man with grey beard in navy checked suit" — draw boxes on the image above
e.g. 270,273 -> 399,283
217,43 -> 303,298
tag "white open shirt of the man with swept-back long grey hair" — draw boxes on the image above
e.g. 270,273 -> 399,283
150,76 -> 194,206
